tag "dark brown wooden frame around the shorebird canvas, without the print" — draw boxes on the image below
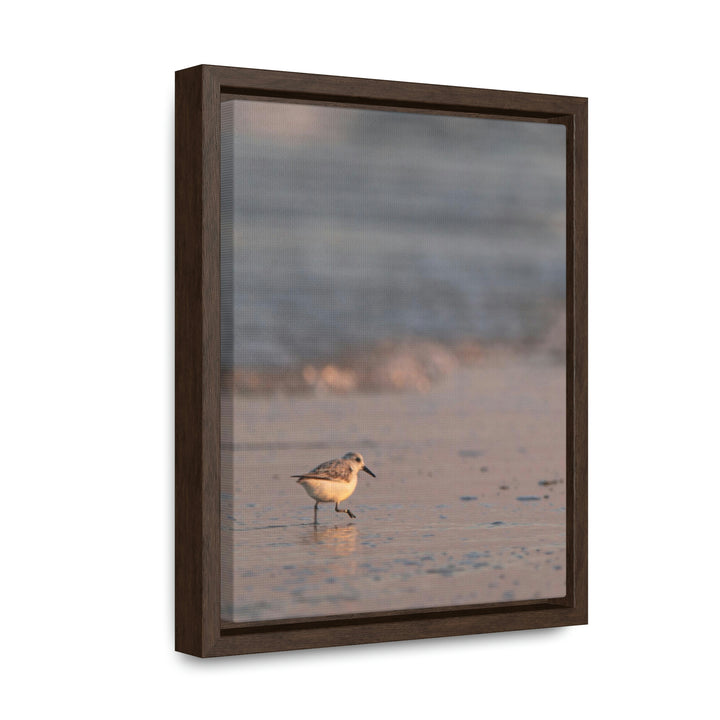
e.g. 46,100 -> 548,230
175,65 -> 588,657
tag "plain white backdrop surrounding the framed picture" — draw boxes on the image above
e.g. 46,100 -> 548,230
0,0 -> 720,718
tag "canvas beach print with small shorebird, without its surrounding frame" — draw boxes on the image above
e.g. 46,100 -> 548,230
221,99 -> 566,624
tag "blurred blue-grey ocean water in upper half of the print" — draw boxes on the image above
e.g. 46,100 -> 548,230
222,100 -> 565,369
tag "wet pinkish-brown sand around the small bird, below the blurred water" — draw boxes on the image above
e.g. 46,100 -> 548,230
222,354 -> 565,622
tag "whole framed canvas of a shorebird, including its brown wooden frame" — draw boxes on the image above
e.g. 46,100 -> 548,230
175,65 -> 587,657
